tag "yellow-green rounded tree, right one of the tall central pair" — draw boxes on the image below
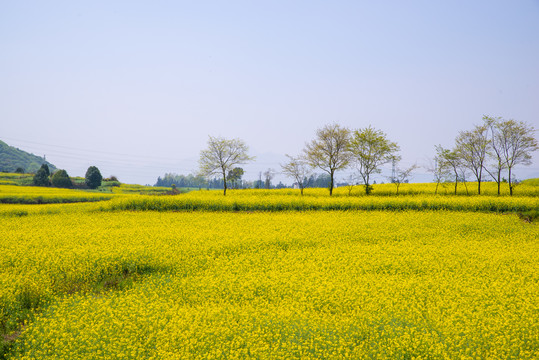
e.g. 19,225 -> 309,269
350,126 -> 400,195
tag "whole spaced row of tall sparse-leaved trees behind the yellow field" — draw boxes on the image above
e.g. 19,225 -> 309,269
199,116 -> 539,196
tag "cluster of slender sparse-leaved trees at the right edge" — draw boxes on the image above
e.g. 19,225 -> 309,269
431,116 -> 539,195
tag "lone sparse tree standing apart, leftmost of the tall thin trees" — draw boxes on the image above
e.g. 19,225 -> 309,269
199,136 -> 254,195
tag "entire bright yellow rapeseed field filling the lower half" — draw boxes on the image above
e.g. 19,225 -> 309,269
0,180 -> 539,359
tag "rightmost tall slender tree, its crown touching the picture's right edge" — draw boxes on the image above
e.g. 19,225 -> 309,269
498,120 -> 539,196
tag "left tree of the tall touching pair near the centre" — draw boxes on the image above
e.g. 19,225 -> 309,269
304,124 -> 350,196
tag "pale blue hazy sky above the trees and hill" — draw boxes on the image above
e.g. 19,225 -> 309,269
0,0 -> 539,184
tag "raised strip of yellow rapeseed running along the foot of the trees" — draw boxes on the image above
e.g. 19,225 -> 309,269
101,189 -> 539,212
